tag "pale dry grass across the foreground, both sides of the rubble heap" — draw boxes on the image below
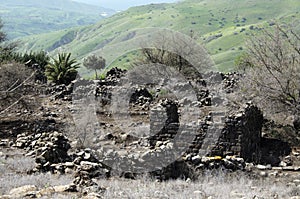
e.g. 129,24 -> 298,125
0,151 -> 300,199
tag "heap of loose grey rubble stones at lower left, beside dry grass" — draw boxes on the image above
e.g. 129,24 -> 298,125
14,132 -> 110,191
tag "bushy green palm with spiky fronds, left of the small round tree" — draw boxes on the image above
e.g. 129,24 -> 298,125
45,53 -> 79,85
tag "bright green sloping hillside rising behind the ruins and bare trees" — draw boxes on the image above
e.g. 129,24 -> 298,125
15,0 -> 300,71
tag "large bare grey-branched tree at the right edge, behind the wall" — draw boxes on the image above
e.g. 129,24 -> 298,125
239,25 -> 300,122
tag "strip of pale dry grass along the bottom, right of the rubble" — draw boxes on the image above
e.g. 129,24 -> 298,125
98,169 -> 300,199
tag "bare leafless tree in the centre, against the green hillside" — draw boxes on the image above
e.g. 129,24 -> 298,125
132,31 -> 212,78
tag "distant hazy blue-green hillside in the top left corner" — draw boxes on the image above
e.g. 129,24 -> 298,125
0,0 -> 115,39
